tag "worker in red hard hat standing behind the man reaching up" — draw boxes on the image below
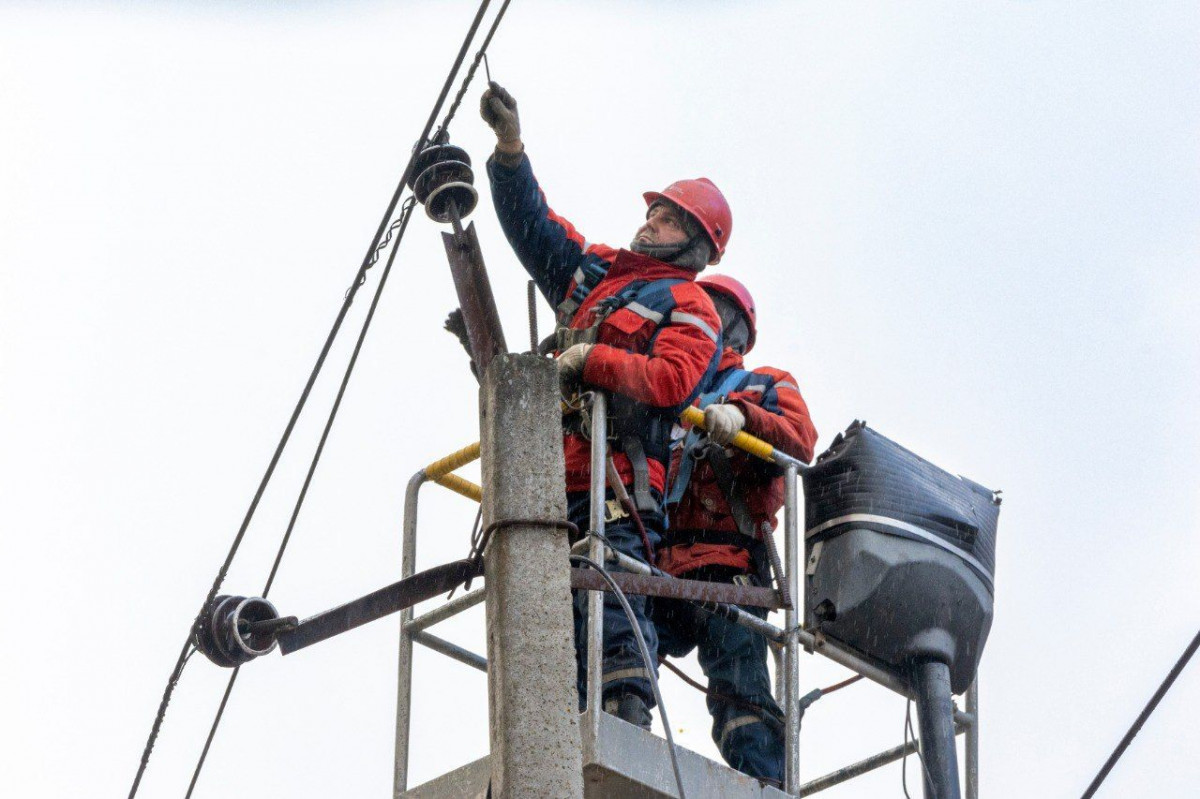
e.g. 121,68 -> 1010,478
653,275 -> 817,785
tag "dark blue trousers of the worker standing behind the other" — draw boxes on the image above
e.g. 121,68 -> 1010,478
654,575 -> 784,783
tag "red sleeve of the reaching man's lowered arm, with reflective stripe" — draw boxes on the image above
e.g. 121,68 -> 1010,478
583,282 -> 721,408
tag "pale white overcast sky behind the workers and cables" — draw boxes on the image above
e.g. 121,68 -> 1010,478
0,0 -> 1200,798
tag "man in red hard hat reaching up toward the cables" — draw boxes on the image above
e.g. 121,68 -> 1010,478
480,83 -> 732,728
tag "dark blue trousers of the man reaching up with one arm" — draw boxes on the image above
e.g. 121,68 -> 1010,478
566,492 -> 664,710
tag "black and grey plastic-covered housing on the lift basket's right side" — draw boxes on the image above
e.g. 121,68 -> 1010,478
804,421 -> 1000,693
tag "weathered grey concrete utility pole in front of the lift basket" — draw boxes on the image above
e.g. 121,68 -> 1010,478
479,354 -> 583,799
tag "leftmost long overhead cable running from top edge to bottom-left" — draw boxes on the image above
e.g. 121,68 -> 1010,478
128,0 -> 508,799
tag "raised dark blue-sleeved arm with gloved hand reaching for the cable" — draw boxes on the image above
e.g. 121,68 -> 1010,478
480,83 -> 616,306
